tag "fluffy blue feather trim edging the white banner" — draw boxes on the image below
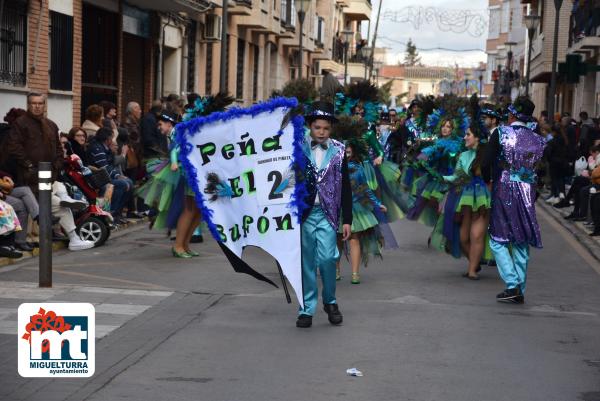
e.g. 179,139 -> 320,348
175,97 -> 307,242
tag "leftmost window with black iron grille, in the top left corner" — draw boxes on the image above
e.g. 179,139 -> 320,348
0,1 -> 27,86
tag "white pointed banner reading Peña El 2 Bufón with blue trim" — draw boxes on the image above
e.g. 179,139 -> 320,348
176,98 -> 306,305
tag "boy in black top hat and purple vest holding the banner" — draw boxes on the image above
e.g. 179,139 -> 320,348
296,101 -> 352,328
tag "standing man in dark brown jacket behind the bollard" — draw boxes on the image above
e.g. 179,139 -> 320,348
6,93 -> 63,193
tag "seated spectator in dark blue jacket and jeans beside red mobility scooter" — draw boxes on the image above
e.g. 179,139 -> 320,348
88,127 -> 133,224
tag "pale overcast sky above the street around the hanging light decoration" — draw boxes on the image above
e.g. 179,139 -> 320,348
364,0 -> 488,67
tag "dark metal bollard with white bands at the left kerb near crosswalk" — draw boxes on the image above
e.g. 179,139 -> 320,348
38,162 -> 52,287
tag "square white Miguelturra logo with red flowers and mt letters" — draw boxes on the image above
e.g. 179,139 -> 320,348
18,303 -> 96,377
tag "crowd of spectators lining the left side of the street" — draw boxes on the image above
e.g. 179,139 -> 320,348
0,93 -> 184,258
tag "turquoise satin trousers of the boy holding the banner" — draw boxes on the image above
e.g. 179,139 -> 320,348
299,205 -> 340,316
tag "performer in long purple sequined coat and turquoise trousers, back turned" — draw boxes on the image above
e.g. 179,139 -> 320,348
482,97 -> 545,304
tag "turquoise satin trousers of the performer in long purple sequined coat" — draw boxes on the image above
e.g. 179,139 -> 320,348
490,239 -> 529,293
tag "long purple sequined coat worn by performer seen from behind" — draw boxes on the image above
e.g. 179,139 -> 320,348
490,124 -> 544,248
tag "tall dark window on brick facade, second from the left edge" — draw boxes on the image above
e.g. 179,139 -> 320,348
50,11 -> 73,91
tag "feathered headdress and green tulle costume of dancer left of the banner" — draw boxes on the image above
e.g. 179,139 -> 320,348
138,93 -> 234,229
